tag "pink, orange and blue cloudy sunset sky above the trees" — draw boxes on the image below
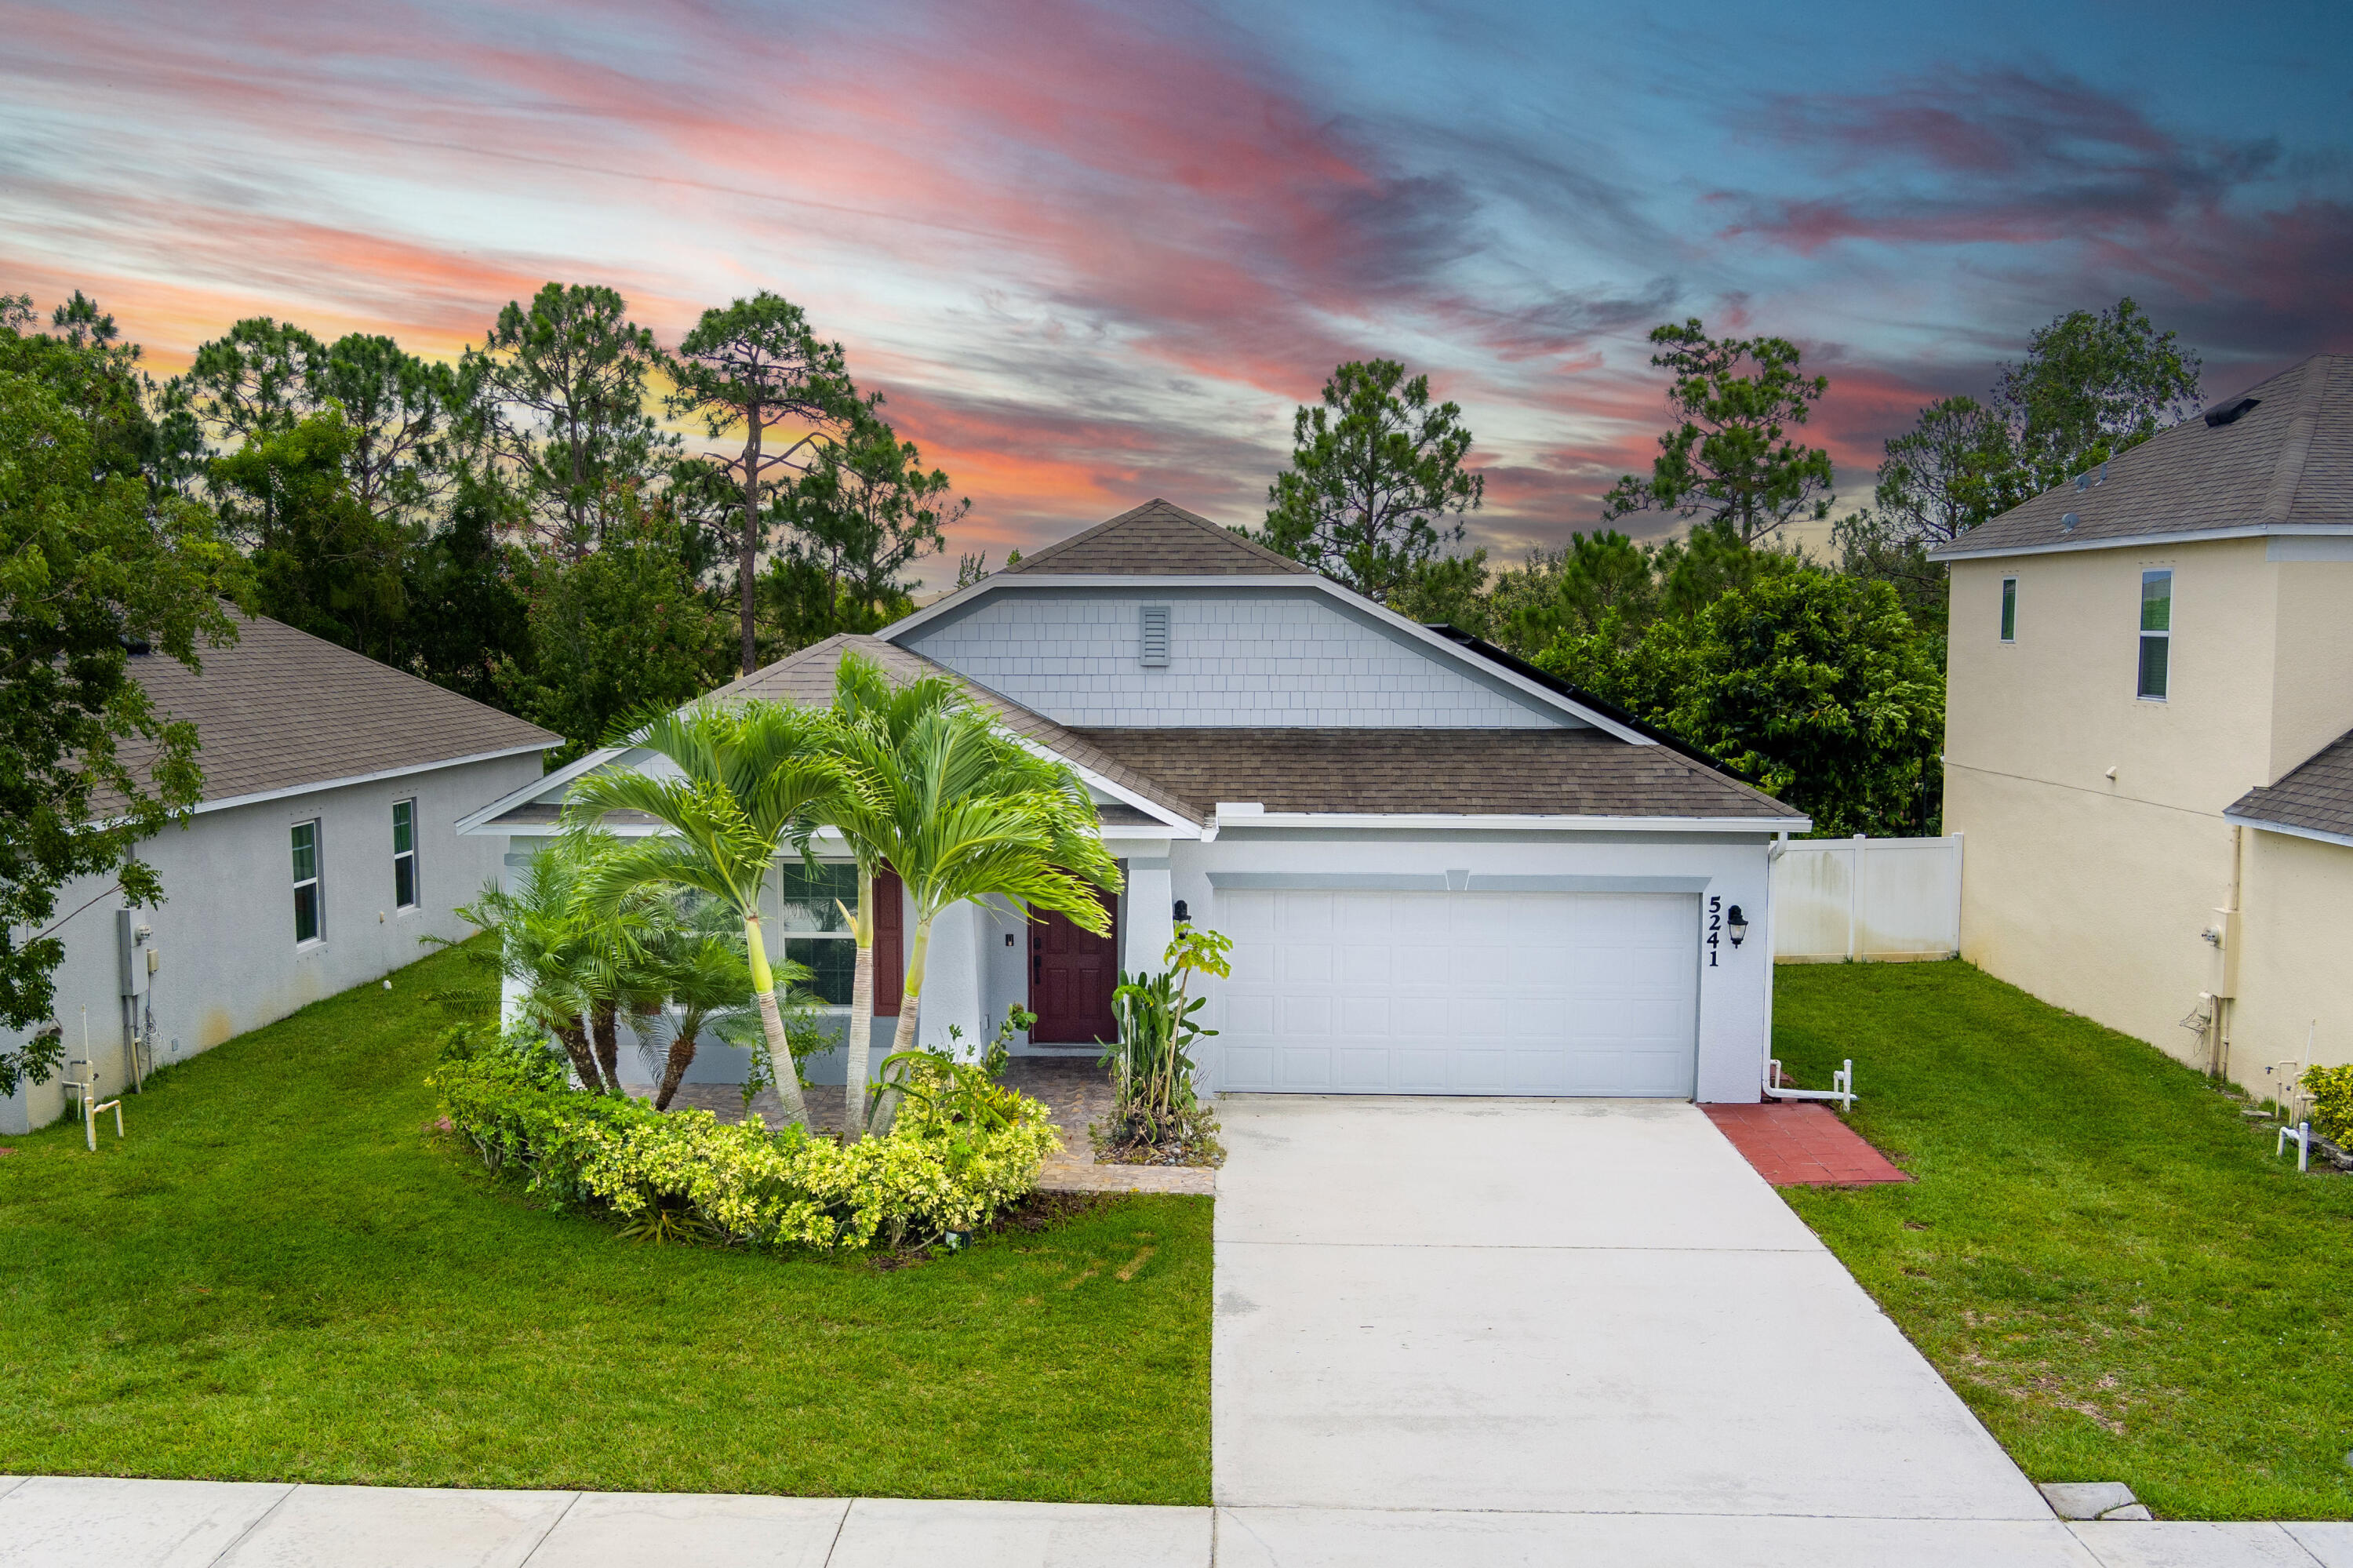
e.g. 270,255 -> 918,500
0,0 -> 2353,572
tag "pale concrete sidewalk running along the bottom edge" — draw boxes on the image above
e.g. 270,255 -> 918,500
0,1476 -> 2353,1568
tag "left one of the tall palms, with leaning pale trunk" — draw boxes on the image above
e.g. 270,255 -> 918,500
565,699 -> 842,1123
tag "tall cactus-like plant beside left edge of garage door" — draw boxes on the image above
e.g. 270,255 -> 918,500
1096,926 -> 1233,1159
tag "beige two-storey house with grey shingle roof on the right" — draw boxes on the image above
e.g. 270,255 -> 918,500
1934,355 -> 2353,1086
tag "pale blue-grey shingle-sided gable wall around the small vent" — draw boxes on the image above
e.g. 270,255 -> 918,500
906,588 -> 1574,729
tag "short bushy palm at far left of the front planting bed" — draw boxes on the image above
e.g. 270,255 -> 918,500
433,834 -> 642,1095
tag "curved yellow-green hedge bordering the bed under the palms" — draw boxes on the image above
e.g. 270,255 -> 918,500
433,1048 -> 1059,1250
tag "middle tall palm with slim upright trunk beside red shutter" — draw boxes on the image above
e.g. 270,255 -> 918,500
828,654 -> 965,1137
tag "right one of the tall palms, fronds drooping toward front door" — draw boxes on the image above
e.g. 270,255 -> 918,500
833,704 -> 1120,1126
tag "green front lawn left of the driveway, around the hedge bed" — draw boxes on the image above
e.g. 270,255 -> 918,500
0,932 -> 1209,1504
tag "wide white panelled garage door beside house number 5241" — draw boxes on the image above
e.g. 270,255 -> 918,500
1217,890 -> 1699,1097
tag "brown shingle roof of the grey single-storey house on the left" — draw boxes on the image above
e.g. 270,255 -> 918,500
107,617 -> 562,813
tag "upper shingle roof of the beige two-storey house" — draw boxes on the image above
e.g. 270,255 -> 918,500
1929,353 -> 2353,555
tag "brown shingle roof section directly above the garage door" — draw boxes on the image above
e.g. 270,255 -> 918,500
1075,727 -> 1800,827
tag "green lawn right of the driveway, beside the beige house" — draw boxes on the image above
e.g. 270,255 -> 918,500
1774,963 -> 2353,1519
